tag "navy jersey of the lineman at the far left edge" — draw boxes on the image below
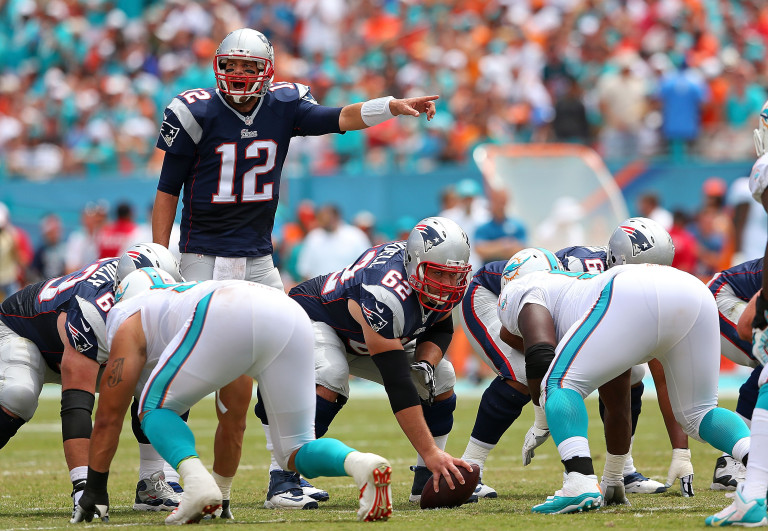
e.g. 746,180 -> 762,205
0,258 -> 118,372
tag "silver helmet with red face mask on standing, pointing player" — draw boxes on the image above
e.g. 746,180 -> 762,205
213,28 -> 275,103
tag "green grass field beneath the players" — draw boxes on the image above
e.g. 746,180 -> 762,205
0,388 -> 735,530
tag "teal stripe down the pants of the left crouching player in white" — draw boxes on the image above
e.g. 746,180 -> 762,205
139,293 -> 213,413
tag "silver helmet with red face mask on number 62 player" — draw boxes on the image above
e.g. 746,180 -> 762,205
405,217 -> 472,312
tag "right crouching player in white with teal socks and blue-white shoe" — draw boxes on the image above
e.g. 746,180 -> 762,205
498,265 -> 750,514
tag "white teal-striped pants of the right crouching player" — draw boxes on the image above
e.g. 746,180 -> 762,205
542,268 -> 720,440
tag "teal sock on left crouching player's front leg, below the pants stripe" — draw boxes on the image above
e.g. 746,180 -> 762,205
141,409 -> 196,470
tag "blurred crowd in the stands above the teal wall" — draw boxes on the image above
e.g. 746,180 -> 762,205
0,0 -> 768,180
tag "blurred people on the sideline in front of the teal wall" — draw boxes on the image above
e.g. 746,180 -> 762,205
0,172 -> 768,301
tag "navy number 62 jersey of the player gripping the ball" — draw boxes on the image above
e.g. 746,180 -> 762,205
288,241 -> 450,354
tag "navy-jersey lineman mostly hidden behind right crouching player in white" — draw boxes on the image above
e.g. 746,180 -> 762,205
462,218 -> 692,498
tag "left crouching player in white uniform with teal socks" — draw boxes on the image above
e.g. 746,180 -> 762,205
72,268 -> 392,524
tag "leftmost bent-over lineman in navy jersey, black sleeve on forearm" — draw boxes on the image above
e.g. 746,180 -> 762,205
0,244 -> 181,520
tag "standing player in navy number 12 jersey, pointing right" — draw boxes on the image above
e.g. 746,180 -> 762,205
152,28 -> 438,507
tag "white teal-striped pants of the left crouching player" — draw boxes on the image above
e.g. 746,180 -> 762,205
139,287 -> 315,467
